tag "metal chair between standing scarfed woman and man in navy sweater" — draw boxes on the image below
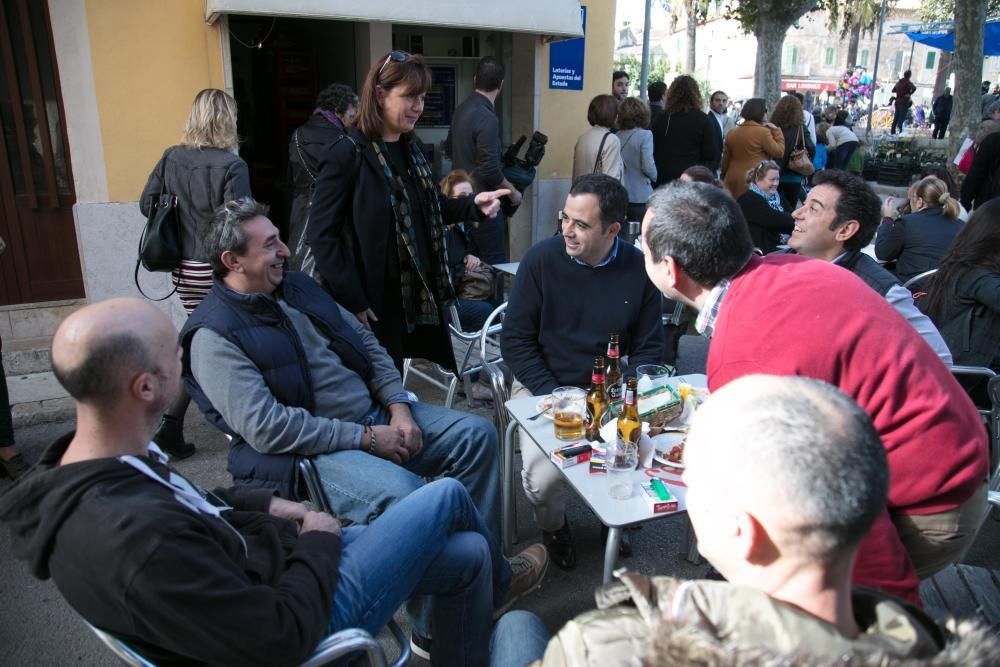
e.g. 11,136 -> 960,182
403,305 -> 501,408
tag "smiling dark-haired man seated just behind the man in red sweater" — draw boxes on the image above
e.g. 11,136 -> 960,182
788,169 -> 952,366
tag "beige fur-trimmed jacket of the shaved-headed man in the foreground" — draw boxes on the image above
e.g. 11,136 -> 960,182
533,572 -> 1000,667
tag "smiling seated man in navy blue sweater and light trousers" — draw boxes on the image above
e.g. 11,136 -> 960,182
501,174 -> 666,569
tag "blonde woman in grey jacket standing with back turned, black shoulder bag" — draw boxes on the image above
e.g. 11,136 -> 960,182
139,88 -> 251,458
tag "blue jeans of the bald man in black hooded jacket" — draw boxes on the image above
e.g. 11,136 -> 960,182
330,479 -> 511,665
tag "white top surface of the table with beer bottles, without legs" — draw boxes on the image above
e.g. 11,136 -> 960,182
507,374 -> 708,527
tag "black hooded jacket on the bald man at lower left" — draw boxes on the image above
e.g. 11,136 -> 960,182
0,433 -> 341,665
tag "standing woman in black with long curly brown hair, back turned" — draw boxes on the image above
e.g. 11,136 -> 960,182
650,74 -> 722,187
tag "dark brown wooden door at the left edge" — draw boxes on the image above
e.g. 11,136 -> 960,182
0,0 -> 84,305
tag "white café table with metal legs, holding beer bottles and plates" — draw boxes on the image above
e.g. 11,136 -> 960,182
503,374 -> 708,583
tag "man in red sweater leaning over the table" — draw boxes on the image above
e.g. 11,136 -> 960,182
643,183 -> 988,601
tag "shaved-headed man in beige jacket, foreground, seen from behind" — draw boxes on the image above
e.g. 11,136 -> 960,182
536,375 -> 1000,667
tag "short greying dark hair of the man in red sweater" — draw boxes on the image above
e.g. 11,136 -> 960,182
644,181 -> 753,287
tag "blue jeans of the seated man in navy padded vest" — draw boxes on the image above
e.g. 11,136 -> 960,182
313,403 -> 500,544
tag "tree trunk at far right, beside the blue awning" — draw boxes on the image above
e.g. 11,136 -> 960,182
949,0 -> 986,154
